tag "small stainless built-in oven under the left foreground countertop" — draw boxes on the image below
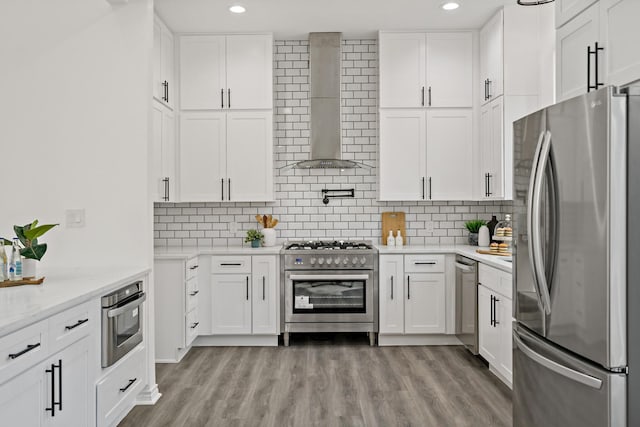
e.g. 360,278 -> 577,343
102,281 -> 147,368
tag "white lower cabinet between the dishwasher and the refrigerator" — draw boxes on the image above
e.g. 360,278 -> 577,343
478,264 -> 513,386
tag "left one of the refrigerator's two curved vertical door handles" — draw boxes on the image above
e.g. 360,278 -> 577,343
530,131 -> 551,315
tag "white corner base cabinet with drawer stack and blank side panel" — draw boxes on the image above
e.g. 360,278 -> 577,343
154,257 -> 200,363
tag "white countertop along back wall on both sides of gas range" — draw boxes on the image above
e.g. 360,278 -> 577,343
154,244 -> 512,273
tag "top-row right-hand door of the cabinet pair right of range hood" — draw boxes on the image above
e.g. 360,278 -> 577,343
426,33 -> 473,108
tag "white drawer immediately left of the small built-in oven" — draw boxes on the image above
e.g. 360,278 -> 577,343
49,302 -> 94,353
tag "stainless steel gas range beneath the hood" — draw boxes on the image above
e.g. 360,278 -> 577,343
280,241 -> 378,345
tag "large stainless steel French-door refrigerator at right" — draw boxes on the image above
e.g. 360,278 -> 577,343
513,86 -> 640,427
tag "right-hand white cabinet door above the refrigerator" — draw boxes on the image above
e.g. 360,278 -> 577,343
600,0 -> 640,86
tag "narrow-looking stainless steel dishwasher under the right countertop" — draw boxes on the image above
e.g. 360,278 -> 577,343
456,255 -> 478,355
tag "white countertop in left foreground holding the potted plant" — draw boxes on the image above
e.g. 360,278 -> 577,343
0,267 -> 150,336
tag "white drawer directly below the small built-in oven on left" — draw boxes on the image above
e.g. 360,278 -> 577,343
97,346 -> 146,426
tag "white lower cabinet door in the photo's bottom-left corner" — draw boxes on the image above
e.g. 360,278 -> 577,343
0,364 -> 46,427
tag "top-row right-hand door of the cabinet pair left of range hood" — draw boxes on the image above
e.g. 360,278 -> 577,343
225,35 -> 273,110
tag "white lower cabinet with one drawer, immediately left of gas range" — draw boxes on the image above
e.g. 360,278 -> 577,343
211,255 -> 279,335
